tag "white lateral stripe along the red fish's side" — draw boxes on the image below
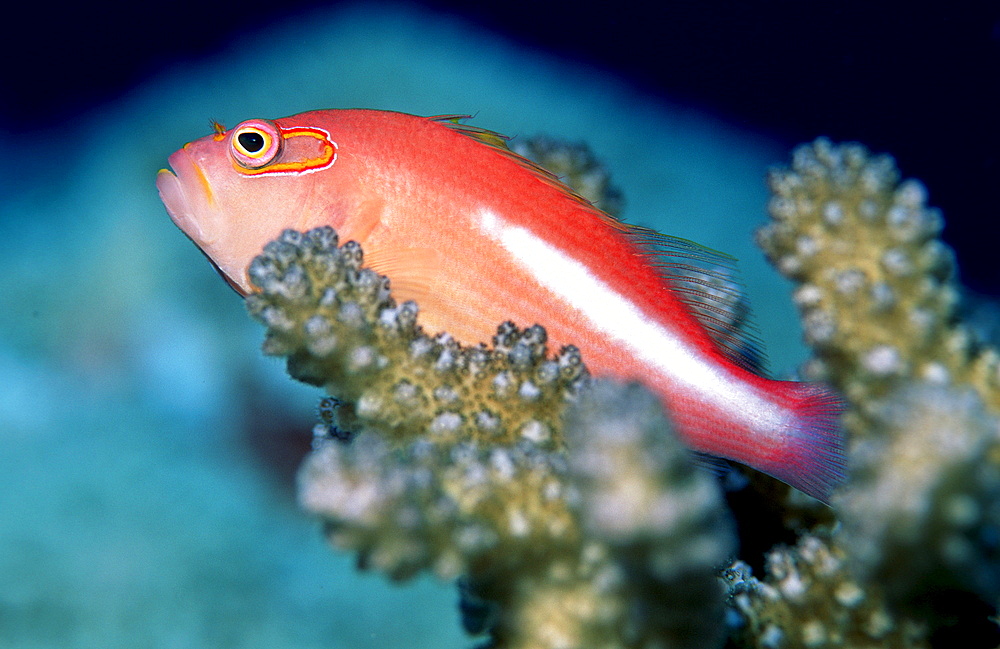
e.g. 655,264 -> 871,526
479,209 -> 787,432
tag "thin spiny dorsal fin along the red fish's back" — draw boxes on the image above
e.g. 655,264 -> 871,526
428,115 -> 765,373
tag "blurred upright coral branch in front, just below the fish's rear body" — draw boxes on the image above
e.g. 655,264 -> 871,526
566,383 -> 736,647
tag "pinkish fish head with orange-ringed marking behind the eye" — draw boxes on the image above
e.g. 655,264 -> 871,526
156,117 -> 349,295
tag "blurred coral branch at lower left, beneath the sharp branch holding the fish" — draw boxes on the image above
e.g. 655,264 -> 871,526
299,434 -> 580,579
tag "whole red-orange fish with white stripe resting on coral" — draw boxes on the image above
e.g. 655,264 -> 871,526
156,109 -> 844,503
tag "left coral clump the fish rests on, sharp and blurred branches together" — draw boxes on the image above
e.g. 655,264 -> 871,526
247,228 -> 734,649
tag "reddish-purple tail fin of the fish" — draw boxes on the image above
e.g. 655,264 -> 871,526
767,382 -> 846,504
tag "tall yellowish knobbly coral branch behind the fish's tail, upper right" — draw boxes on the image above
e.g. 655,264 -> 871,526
757,139 -> 1000,426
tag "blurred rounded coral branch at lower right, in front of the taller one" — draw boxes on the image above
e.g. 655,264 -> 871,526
837,383 -> 1000,599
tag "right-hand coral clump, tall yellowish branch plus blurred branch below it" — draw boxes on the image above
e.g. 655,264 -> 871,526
755,139 -> 1000,646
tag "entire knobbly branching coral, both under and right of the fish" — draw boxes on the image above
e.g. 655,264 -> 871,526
238,134 -> 1000,649
